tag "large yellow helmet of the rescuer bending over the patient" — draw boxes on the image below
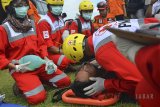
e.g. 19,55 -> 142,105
62,33 -> 85,62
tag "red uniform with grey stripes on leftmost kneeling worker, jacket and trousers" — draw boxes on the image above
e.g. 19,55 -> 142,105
0,22 -> 70,104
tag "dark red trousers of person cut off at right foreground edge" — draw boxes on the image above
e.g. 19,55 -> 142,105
135,45 -> 160,107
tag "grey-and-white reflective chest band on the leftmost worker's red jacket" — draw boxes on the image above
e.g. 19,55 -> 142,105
2,22 -> 36,42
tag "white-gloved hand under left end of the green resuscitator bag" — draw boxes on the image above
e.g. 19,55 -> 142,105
15,62 -> 31,73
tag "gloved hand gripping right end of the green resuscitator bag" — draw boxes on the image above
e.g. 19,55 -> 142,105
45,58 -> 57,74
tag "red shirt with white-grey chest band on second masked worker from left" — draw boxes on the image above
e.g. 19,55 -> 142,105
38,13 -> 64,47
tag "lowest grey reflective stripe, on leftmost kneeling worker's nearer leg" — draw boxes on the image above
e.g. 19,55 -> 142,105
24,84 -> 44,97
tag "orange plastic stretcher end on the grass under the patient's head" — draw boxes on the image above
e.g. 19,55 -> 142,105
62,89 -> 119,106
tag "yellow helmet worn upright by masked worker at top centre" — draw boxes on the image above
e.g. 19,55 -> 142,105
79,0 -> 94,11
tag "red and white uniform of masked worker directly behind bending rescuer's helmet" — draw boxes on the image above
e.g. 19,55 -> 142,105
70,16 -> 94,37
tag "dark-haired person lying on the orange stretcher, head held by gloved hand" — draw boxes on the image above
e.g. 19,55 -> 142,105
71,62 -> 116,99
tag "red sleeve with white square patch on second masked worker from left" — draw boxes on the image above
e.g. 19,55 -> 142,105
37,21 -> 53,47
